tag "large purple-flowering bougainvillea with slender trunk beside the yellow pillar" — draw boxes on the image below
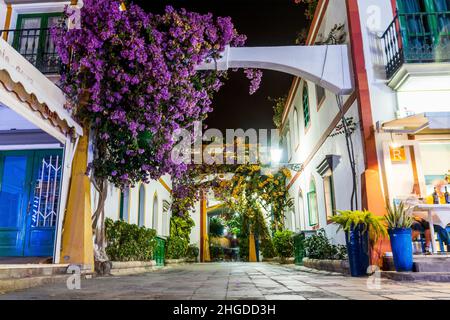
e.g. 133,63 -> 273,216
52,0 -> 260,261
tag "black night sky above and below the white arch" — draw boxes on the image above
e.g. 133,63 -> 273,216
134,0 -> 305,130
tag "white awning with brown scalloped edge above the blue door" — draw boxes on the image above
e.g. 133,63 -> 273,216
0,39 -> 83,136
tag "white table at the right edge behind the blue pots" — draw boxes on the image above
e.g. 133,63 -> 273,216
413,204 -> 450,253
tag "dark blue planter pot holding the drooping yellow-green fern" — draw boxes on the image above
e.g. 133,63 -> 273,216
345,225 -> 369,277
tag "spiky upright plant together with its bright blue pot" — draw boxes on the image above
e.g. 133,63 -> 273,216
385,202 -> 414,271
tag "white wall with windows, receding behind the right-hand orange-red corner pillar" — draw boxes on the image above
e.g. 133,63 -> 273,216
284,0 -> 365,243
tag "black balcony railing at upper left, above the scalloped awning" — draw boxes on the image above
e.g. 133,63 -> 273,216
0,28 -> 61,74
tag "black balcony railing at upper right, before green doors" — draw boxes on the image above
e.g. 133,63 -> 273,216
381,11 -> 450,78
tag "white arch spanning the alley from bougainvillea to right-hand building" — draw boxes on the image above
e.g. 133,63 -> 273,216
197,45 -> 354,95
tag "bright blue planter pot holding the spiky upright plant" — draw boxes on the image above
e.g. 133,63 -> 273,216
388,228 -> 413,272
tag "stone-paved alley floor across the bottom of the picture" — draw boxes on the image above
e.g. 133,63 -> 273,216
0,263 -> 450,300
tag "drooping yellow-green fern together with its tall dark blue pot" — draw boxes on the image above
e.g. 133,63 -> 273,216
331,210 -> 387,277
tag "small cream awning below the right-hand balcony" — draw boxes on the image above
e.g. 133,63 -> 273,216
382,112 -> 450,134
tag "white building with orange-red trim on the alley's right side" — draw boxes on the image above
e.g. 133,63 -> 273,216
281,0 -> 450,258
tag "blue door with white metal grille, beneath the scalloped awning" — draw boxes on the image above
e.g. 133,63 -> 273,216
0,150 -> 62,257
